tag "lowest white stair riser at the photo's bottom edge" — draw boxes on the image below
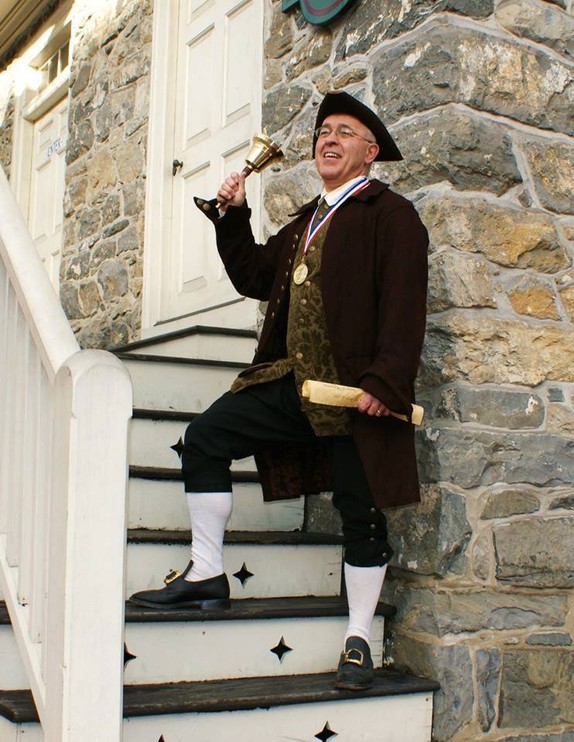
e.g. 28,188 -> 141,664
123,693 -> 432,742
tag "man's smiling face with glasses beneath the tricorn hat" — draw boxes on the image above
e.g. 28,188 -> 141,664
315,114 -> 379,191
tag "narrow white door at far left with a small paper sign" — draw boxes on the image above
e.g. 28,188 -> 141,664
28,93 -> 68,291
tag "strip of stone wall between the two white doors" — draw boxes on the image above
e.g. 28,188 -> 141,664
61,0 -> 152,348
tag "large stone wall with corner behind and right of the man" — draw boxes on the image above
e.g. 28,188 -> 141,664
263,0 -> 574,742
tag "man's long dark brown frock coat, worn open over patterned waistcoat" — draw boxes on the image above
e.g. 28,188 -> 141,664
212,180 -> 428,508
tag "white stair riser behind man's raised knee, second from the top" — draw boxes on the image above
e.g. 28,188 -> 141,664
124,360 -> 240,412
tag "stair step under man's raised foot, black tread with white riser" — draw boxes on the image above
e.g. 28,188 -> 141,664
125,597 -> 393,685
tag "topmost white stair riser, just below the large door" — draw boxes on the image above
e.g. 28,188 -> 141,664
127,334 -> 256,364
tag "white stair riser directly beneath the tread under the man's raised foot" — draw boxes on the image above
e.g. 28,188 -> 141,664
125,616 -> 384,684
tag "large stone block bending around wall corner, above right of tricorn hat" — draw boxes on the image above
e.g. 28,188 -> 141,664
373,19 -> 574,134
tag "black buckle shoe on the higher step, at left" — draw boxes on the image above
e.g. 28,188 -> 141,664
129,562 -> 229,610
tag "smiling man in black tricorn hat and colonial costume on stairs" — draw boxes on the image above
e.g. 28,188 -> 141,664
131,92 -> 428,690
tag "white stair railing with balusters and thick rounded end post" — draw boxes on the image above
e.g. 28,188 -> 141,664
0,169 -> 132,742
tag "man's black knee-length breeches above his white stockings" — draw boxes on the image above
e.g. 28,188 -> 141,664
182,374 -> 392,567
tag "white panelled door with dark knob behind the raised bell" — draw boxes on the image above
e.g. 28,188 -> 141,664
160,0 -> 263,322
